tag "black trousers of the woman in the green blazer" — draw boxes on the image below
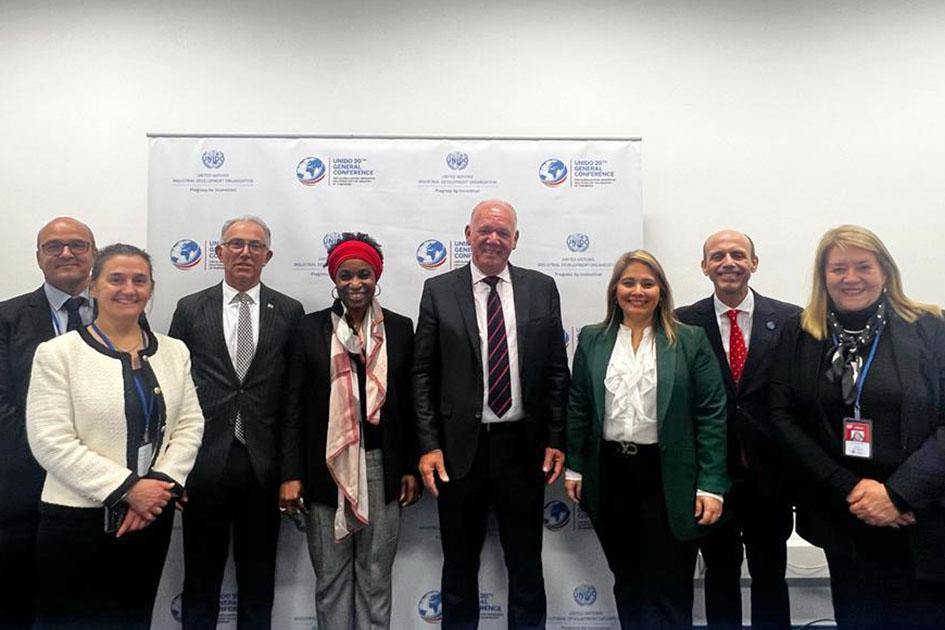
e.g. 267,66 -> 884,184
594,442 -> 696,630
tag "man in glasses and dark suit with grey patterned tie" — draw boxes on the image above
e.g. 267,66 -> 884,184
170,216 -> 303,630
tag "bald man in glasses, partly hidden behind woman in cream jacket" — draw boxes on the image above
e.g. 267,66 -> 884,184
0,217 -> 95,630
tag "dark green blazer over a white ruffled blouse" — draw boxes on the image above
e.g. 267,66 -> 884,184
567,324 -> 730,540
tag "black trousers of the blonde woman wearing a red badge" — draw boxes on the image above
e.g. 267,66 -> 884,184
825,528 -> 945,630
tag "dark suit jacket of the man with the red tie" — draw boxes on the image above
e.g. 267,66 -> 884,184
676,290 -> 801,493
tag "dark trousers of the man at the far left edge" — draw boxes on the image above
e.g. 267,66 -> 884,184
0,514 -> 39,630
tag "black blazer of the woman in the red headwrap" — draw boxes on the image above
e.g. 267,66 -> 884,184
280,308 -> 417,506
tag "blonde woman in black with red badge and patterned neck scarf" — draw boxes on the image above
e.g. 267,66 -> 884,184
770,225 -> 945,628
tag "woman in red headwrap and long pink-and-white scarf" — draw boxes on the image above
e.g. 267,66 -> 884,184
279,233 -> 419,628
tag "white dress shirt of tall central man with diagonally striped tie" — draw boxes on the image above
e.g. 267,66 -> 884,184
469,263 -> 525,423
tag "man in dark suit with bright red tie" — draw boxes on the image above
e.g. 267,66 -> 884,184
676,230 -> 800,629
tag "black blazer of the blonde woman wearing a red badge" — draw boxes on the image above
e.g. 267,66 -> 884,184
771,309 -> 945,580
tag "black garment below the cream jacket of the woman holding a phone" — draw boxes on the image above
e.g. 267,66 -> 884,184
33,504 -> 174,630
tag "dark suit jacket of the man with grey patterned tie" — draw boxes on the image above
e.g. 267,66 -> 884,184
168,283 -> 304,491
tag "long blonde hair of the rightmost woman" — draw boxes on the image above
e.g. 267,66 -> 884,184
801,225 -> 942,339
